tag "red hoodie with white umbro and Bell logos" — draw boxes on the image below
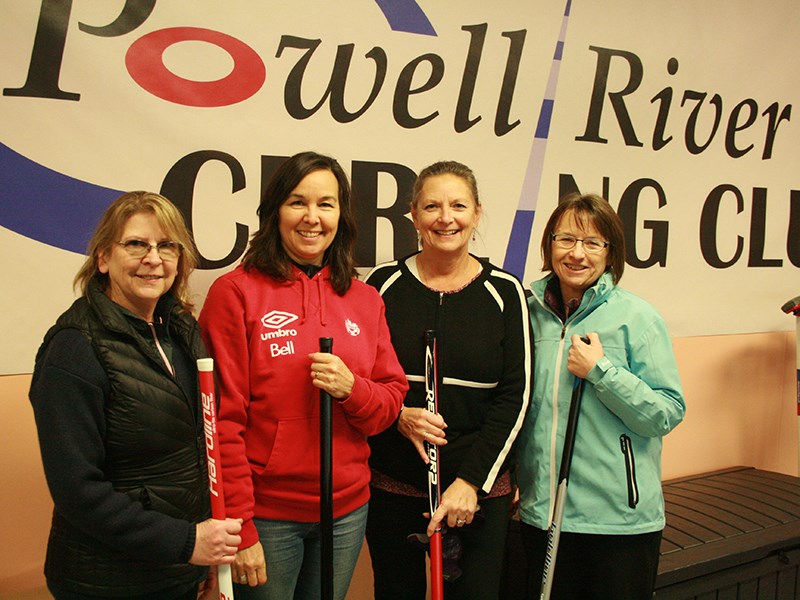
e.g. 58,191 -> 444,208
199,266 -> 408,548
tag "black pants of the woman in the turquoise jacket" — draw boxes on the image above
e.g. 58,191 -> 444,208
522,523 -> 661,600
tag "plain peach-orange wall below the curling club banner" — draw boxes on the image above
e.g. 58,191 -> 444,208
0,332 -> 798,600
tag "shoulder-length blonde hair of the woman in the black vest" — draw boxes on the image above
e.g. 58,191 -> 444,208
72,191 -> 197,313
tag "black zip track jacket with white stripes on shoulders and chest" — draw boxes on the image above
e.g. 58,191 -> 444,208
366,254 -> 533,494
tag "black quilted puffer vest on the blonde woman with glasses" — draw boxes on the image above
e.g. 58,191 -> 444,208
39,281 -> 210,598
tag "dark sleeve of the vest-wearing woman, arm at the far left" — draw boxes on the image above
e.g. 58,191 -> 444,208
30,329 -> 194,564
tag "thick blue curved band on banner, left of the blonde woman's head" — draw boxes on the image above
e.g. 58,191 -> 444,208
0,143 -> 122,254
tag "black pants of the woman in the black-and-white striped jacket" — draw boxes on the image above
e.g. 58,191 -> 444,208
367,488 -> 511,600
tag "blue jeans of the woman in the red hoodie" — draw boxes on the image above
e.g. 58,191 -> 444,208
233,504 -> 368,600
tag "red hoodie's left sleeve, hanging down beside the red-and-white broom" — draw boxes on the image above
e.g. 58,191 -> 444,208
198,276 -> 258,548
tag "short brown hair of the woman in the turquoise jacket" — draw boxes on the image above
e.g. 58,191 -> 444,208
542,192 -> 625,284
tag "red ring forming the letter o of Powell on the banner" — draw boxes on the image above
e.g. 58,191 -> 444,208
125,27 -> 267,107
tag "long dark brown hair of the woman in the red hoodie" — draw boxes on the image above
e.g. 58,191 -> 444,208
242,152 -> 356,296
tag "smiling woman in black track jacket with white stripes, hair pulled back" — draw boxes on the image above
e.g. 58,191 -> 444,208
367,161 -> 532,600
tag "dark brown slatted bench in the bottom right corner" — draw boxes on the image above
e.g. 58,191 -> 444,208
656,467 -> 800,600
